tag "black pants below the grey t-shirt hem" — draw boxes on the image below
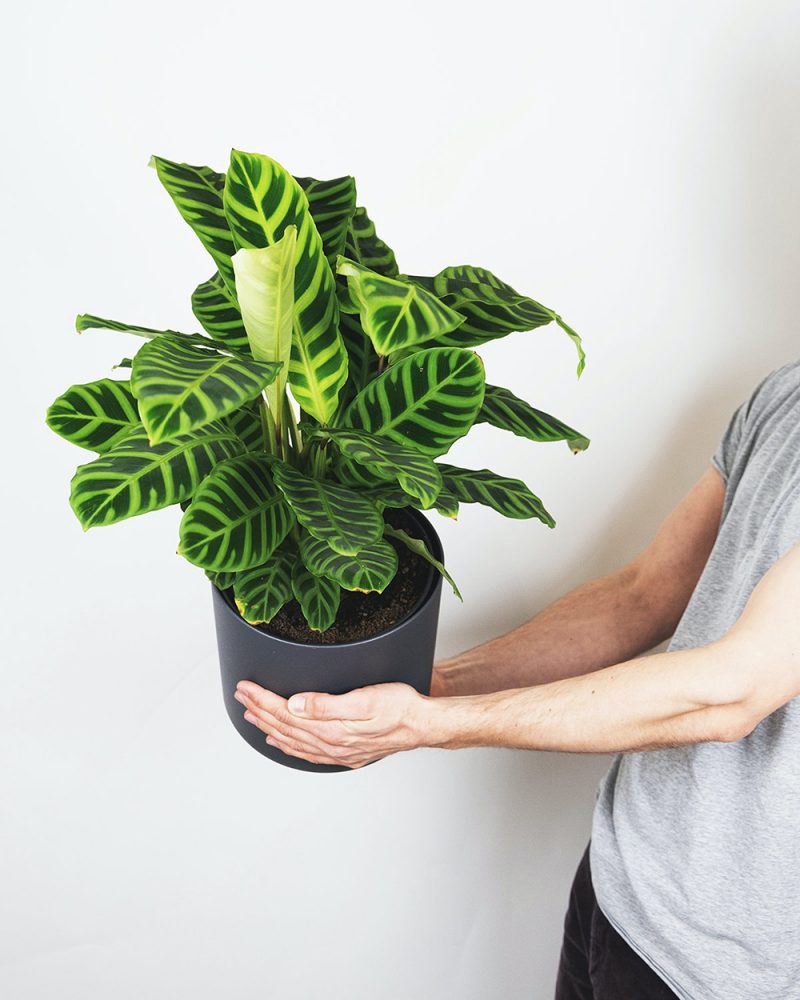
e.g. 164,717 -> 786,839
556,847 -> 677,1000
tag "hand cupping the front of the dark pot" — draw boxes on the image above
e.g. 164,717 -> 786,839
234,681 -> 429,768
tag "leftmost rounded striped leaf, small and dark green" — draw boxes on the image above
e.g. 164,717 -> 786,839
46,378 -> 142,453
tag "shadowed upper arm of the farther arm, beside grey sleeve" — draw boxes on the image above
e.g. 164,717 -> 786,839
630,465 -> 725,639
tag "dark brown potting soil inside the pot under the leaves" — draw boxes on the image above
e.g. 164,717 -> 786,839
244,510 -> 437,645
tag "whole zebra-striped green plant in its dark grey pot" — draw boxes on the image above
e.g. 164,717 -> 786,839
47,150 -> 589,771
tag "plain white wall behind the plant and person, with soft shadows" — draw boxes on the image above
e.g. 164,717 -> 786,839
0,0 -> 800,1000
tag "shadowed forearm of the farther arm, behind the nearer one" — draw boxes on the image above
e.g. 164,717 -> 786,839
431,566 -> 675,696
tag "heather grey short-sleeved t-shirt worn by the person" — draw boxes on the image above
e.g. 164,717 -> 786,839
590,360 -> 800,1000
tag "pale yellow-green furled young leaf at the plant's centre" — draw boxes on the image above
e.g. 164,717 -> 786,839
233,226 -> 297,414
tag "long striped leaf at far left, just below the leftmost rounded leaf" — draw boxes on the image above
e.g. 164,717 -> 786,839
70,422 -> 242,530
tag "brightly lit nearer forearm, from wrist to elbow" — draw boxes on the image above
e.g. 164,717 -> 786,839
422,640 -> 757,753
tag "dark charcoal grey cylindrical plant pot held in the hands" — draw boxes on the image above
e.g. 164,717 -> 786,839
212,508 -> 443,772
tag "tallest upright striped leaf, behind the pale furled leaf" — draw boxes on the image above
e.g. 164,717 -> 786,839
224,150 -> 347,423
